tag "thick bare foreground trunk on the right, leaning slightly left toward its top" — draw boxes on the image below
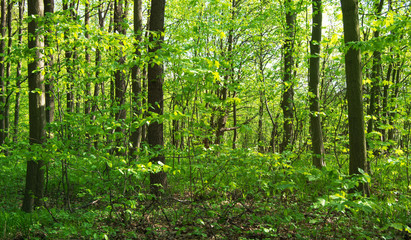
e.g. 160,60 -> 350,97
341,0 -> 370,195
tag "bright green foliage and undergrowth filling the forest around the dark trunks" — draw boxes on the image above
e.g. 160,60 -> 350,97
0,0 -> 411,239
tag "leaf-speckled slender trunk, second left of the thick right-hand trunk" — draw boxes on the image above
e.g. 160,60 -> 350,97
280,0 -> 296,152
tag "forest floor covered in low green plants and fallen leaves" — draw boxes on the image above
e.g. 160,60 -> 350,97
0,147 -> 411,239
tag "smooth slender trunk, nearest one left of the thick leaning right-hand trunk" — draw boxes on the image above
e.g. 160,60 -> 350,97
308,0 -> 325,168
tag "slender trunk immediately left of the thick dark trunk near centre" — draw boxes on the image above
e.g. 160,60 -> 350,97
130,0 -> 145,159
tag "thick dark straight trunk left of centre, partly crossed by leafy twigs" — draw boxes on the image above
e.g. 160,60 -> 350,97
147,0 -> 167,195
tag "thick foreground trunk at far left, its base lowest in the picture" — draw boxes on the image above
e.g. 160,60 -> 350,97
22,0 -> 46,212
